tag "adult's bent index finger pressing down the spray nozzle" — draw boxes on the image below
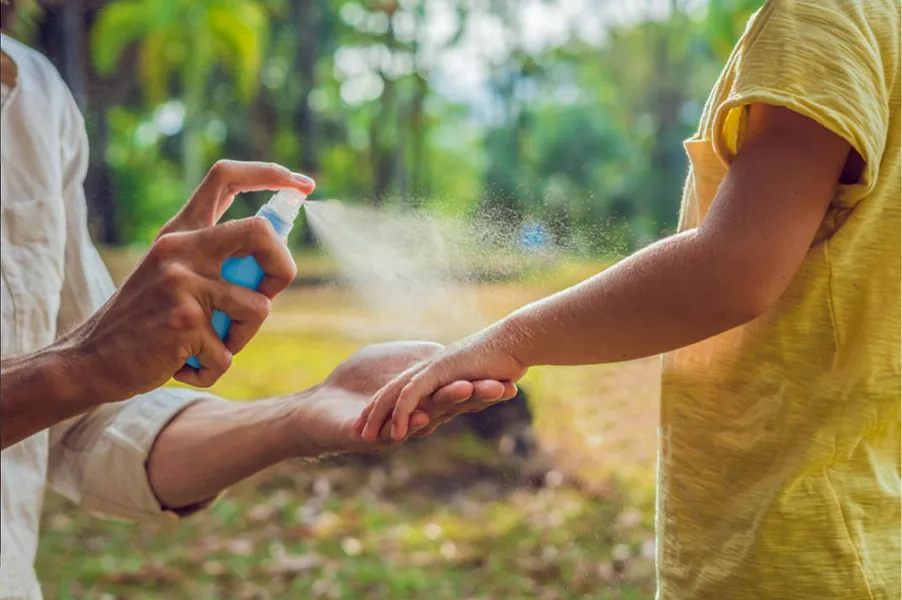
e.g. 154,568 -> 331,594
170,160 -> 316,233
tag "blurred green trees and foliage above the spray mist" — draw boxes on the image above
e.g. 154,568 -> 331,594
26,0 -> 761,252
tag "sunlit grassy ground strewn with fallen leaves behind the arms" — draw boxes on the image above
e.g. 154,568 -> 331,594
37,257 -> 657,600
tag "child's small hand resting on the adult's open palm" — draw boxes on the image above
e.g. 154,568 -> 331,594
354,332 -> 526,440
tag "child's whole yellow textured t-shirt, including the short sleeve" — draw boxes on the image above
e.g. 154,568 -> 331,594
657,0 -> 902,600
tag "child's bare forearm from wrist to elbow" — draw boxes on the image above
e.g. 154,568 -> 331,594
495,230 -> 766,367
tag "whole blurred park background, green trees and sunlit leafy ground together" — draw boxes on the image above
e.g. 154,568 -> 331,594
10,0 -> 761,600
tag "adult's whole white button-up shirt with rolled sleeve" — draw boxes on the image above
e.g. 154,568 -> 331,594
0,36 -> 217,600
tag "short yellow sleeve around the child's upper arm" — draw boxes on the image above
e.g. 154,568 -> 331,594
712,0 -> 889,205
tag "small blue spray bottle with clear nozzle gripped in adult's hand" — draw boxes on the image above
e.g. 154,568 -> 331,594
186,189 -> 307,369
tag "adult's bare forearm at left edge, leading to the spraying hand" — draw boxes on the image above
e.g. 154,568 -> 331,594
0,343 -> 98,449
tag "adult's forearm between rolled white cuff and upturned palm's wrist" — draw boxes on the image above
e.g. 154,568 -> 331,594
147,398 -> 303,509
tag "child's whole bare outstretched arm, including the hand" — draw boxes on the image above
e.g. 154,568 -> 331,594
357,104 -> 857,439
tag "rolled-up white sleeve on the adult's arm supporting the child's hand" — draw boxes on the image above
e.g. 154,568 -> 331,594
48,86 -> 224,521
